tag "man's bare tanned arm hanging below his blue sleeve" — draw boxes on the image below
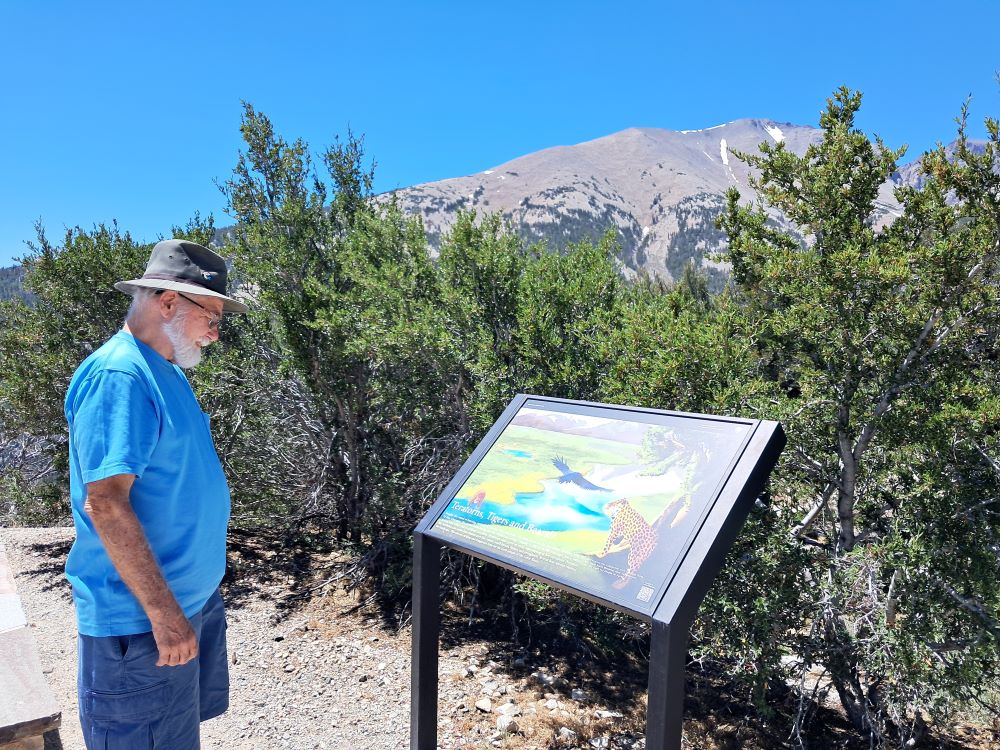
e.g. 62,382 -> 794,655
83,474 -> 198,667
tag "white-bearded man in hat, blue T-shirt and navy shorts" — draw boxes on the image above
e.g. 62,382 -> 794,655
65,240 -> 247,750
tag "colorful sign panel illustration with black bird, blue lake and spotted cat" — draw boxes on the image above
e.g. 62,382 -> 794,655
432,406 -> 749,606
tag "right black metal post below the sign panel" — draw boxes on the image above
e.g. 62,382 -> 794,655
646,620 -> 688,750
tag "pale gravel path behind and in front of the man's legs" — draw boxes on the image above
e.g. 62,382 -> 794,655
3,529 -> 410,750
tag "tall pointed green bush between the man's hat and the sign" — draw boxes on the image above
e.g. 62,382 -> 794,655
225,105 -> 464,542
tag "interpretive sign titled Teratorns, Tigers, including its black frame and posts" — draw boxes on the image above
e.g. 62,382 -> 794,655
410,395 -> 785,750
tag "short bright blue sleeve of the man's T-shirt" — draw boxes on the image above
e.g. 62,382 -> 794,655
70,370 -> 160,483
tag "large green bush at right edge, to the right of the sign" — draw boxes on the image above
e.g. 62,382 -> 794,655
721,89 -> 1000,744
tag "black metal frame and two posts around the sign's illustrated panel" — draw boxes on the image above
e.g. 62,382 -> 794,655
410,394 -> 785,750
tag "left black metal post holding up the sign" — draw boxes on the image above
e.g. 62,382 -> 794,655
410,531 -> 441,750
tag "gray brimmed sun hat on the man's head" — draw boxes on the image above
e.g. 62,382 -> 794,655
115,240 -> 249,312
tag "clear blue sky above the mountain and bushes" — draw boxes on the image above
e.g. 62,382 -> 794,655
0,0 -> 1000,266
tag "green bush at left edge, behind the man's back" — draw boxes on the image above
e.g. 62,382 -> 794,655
0,225 -> 149,521
